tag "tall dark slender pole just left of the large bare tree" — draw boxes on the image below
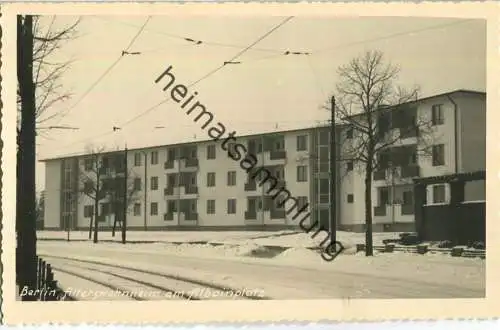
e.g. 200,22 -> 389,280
330,96 -> 337,252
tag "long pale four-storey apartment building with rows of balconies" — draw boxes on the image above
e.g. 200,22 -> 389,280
43,90 -> 486,231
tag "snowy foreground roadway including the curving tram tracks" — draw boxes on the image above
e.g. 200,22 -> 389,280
38,242 -> 485,300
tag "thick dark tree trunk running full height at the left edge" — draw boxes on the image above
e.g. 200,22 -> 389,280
16,15 -> 37,301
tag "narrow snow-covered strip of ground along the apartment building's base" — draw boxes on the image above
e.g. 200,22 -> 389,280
37,229 -> 399,248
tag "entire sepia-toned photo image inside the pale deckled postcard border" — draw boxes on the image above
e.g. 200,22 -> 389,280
3,1 -> 490,321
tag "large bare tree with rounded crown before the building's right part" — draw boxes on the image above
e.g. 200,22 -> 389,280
328,51 -> 430,256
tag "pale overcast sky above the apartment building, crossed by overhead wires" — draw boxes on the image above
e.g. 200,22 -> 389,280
37,16 -> 486,189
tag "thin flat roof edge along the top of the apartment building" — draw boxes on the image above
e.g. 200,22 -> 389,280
39,89 -> 486,162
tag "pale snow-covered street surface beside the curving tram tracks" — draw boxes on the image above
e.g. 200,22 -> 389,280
38,242 -> 486,299
